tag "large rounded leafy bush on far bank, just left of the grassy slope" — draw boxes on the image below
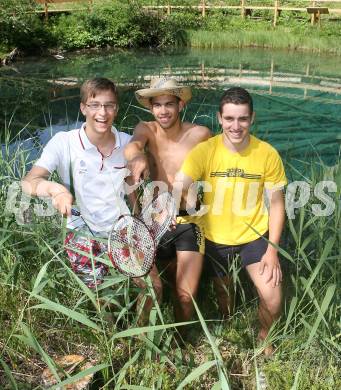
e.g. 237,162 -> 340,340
50,2 -> 185,49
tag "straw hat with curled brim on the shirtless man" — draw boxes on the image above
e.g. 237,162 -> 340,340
135,77 -> 192,108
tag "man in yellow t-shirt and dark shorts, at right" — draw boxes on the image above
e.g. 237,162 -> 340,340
177,87 -> 286,354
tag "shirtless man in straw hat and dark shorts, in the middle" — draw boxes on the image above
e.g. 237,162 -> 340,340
125,78 -> 211,334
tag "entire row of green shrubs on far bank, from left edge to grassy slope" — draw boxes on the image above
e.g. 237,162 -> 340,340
0,0 -> 184,52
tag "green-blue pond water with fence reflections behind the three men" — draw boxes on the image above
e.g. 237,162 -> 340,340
0,49 -> 341,164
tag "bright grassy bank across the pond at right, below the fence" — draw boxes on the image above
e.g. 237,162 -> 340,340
137,0 -> 341,55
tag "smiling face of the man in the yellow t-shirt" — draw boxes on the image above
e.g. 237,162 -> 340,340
218,103 -> 254,151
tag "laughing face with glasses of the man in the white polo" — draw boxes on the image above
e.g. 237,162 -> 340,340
80,90 -> 118,135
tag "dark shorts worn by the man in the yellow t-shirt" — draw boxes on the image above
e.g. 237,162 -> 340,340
205,233 -> 268,277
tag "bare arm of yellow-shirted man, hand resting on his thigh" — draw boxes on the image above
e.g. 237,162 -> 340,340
259,189 -> 285,287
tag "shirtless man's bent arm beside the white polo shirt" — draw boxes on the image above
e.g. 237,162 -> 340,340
124,122 -> 150,183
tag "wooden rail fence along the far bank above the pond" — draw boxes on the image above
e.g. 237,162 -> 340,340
36,0 -> 341,26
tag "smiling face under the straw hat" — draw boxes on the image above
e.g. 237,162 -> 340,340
150,95 -> 184,130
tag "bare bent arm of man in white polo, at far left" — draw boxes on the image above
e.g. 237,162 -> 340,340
21,165 -> 73,215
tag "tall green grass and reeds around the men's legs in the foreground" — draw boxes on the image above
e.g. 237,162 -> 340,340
0,122 -> 341,390
